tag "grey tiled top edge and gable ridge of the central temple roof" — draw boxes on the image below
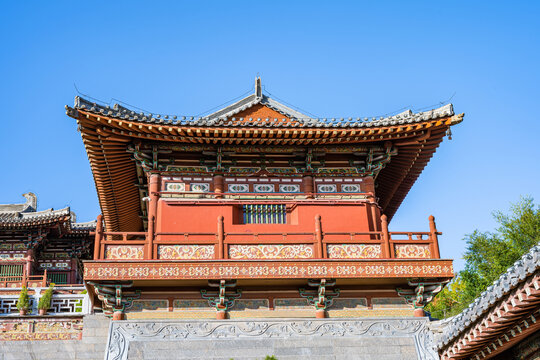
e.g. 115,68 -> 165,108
66,94 -> 463,128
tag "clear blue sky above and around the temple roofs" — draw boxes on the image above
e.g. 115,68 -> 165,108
0,1 -> 540,269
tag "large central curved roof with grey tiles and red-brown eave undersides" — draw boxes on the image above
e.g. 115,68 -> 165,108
66,83 -> 463,231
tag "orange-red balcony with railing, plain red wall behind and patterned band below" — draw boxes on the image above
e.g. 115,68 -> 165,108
84,186 -> 453,286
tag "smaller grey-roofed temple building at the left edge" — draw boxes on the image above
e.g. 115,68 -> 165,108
0,193 -> 96,288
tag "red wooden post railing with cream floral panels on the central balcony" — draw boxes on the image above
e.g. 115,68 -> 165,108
90,215 -> 442,260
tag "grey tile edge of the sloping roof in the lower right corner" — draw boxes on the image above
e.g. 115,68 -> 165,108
437,244 -> 540,349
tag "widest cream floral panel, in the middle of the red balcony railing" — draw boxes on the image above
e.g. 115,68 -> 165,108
229,244 -> 313,260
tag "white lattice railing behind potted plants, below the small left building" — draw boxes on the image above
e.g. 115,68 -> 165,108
0,286 -> 91,317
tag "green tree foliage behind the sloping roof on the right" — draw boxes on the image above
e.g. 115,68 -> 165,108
427,197 -> 540,318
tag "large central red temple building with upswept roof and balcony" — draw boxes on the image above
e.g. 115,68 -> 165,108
66,78 -> 463,319
